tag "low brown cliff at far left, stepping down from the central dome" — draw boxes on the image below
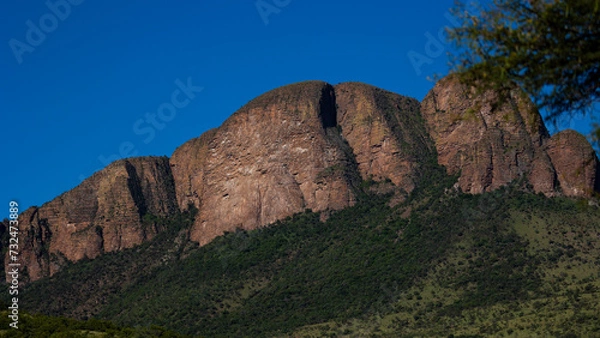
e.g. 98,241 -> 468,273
8,157 -> 178,281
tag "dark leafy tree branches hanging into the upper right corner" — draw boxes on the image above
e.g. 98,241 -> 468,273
448,0 -> 600,122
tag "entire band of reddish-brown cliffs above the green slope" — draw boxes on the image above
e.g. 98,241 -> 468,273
5,77 -> 600,282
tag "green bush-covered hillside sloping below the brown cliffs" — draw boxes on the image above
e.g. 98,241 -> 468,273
12,169 -> 600,337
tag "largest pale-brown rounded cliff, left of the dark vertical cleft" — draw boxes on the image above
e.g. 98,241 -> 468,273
173,81 -> 354,245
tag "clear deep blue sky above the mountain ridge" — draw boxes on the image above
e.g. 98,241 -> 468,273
0,0 -> 588,213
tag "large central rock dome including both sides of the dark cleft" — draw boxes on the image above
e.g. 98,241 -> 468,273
171,81 -> 433,244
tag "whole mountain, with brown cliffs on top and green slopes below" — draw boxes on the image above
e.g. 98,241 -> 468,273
0,77 -> 600,336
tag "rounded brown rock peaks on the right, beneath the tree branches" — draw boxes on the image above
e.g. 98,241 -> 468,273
421,77 -> 596,196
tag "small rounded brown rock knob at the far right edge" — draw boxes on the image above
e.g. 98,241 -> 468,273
547,130 -> 599,197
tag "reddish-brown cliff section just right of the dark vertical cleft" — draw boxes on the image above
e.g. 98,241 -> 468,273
335,83 -> 435,192
